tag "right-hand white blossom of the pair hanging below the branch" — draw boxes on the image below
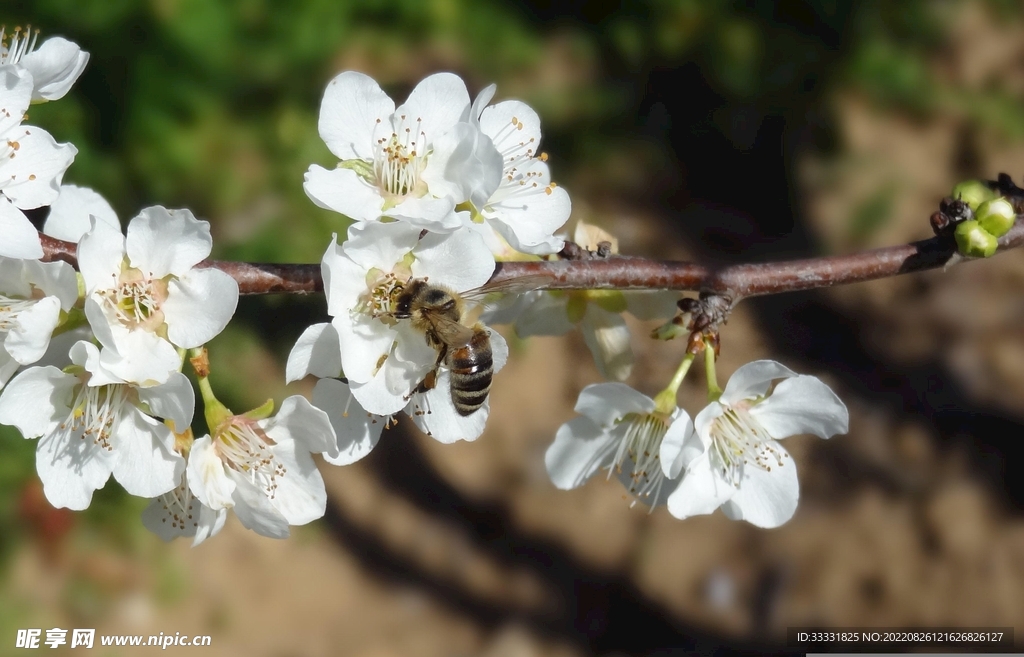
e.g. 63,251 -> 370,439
669,360 -> 850,527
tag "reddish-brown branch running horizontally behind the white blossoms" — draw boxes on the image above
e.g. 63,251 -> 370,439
40,221 -> 1024,300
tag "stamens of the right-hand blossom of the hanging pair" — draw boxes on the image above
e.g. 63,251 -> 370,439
711,406 -> 785,488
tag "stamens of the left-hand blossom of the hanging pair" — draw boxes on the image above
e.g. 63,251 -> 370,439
608,412 -> 669,511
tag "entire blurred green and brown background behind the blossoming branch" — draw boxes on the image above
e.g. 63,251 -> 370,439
0,0 -> 1024,657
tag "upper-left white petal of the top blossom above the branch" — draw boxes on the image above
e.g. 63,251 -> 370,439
317,71 -> 394,162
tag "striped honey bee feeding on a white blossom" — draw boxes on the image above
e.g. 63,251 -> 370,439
390,276 -> 549,417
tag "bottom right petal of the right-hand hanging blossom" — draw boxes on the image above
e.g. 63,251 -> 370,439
722,443 -> 800,529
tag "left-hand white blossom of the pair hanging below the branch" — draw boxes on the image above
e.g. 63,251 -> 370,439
544,383 -> 693,509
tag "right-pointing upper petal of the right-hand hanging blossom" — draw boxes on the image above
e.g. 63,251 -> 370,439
751,375 -> 850,438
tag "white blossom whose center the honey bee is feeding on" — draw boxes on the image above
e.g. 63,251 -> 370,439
323,222 -> 495,415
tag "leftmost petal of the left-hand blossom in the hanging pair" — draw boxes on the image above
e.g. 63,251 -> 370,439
544,413 -> 617,490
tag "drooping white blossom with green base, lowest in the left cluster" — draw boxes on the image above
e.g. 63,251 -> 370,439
187,396 -> 337,538
